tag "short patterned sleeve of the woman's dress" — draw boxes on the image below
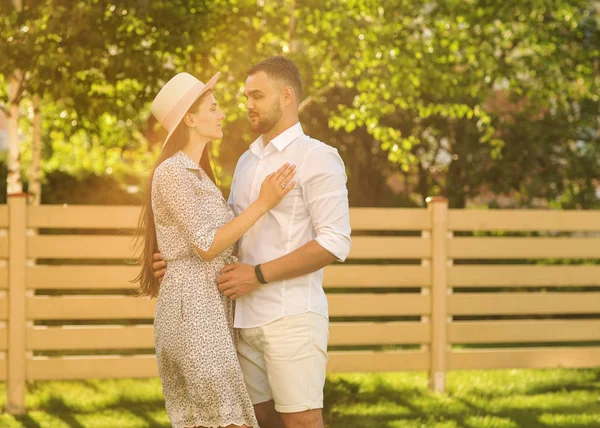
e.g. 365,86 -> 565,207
152,163 -> 219,251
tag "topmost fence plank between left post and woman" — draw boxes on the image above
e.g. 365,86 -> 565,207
27,205 -> 141,229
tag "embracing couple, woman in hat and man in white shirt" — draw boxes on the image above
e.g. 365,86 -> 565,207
138,57 -> 351,428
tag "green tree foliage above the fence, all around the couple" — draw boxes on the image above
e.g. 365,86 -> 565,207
0,0 -> 600,208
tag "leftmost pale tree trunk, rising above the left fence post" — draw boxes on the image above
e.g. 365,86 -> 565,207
6,70 -> 23,195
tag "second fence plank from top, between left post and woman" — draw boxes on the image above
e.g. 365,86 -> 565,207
27,235 -> 135,259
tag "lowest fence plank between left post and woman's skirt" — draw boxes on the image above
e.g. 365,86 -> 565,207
26,355 -> 158,380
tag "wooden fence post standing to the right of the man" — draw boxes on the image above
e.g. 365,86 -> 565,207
427,197 -> 448,392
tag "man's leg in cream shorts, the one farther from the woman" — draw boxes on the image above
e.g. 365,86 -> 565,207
261,312 -> 329,428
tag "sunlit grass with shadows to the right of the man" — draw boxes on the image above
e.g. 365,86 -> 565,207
324,370 -> 600,428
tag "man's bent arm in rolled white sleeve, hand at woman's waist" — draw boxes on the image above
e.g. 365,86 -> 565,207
217,146 -> 352,299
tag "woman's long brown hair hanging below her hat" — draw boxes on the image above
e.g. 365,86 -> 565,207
133,91 -> 215,297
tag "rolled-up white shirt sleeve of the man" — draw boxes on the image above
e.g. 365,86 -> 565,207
299,145 -> 352,262
